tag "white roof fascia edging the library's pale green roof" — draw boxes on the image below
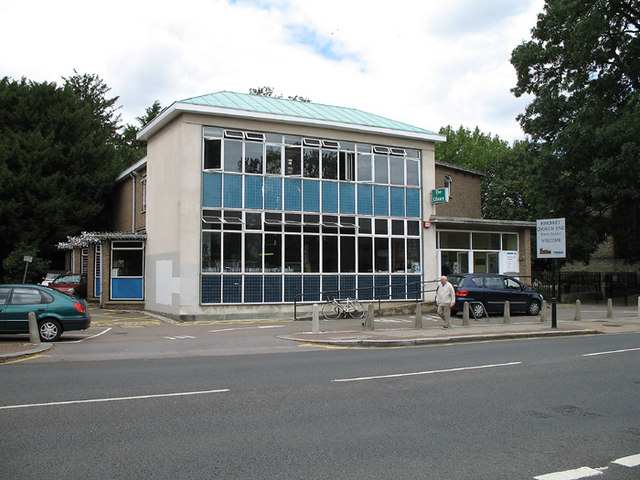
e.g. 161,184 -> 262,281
137,102 -> 447,143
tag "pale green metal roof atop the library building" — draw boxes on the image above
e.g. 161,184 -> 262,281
177,91 -> 438,135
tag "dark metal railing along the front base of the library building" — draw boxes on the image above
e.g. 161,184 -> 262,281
293,279 -> 439,320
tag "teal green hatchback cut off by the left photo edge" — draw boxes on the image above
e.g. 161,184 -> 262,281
0,285 -> 91,342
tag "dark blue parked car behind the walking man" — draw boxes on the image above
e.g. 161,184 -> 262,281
448,273 -> 542,318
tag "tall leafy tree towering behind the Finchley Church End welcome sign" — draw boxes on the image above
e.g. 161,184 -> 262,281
511,0 -> 640,261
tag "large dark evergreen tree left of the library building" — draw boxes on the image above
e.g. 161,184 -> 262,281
0,76 -> 120,278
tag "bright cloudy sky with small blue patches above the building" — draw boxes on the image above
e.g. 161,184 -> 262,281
0,0 -> 544,141
